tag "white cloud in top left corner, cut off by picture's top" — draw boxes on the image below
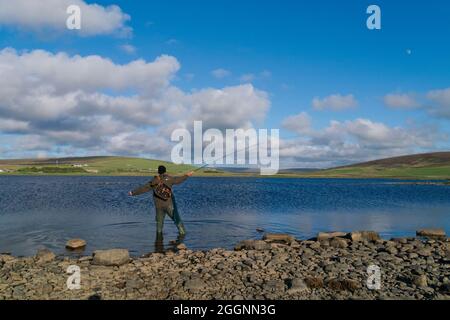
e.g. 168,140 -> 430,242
0,0 -> 132,36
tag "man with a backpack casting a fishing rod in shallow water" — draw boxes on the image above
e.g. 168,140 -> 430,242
128,166 -> 193,239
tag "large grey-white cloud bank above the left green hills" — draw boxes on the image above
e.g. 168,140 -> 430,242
0,49 -> 270,159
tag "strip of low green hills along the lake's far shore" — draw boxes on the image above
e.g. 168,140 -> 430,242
0,152 -> 450,180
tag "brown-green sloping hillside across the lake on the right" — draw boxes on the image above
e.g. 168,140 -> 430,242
312,152 -> 450,179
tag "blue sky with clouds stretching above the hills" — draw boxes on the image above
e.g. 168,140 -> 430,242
0,0 -> 450,166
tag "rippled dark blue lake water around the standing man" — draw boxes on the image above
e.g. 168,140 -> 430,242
0,176 -> 450,255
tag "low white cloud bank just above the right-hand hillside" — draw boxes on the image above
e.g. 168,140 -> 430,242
280,113 -> 446,167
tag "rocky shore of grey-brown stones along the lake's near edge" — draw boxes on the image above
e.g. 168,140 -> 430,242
0,230 -> 450,300
